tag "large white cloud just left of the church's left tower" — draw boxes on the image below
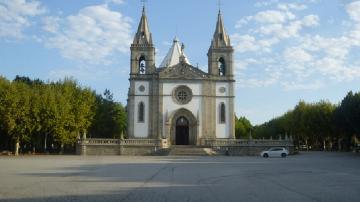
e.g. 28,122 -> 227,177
43,4 -> 131,64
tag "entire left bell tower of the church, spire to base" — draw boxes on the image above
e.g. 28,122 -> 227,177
127,6 -> 158,138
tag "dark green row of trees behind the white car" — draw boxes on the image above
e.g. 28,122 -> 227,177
253,92 -> 360,150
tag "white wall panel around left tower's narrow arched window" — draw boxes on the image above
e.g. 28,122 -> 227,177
134,81 -> 150,138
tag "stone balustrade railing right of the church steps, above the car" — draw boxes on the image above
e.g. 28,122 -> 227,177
202,138 -> 293,147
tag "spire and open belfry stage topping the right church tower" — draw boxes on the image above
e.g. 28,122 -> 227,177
207,10 -> 234,79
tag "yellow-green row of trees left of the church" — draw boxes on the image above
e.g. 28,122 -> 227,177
0,76 -> 126,154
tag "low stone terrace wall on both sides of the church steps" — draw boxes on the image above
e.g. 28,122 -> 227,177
76,139 -> 295,156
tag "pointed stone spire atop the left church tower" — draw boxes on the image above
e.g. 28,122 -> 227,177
133,4 -> 152,44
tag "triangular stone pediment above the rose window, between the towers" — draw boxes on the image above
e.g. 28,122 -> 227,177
159,63 -> 208,79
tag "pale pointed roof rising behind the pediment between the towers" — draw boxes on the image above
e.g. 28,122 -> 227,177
159,37 -> 190,68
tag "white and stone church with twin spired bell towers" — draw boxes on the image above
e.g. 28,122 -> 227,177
127,8 -> 235,145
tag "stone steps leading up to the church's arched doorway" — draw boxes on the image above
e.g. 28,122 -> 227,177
169,145 -> 216,156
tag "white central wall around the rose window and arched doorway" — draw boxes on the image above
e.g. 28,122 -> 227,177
162,82 -> 202,137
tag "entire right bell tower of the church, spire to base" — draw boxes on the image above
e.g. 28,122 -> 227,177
204,9 -> 235,139
